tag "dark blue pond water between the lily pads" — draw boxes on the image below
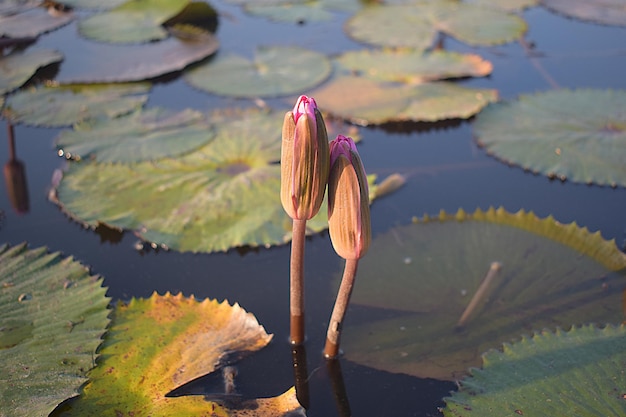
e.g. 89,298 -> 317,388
0,2 -> 626,416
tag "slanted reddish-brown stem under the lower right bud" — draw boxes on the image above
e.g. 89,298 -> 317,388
324,259 -> 359,359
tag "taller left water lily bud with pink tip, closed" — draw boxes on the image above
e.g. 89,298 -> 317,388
280,96 -> 330,220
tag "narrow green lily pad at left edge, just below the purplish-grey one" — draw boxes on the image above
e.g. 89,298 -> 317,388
4,83 -> 151,127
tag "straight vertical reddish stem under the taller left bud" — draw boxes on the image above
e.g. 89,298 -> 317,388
289,219 -> 306,345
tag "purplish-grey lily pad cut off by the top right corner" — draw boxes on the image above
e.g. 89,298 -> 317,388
541,0 -> 626,26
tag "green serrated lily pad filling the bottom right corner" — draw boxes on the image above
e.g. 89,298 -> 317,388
443,324 -> 626,417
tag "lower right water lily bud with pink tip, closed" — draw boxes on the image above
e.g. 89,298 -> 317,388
328,135 -> 372,259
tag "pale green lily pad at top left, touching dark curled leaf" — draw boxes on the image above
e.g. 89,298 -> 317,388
78,0 -> 189,43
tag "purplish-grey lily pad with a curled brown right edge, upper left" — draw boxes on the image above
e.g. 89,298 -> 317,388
58,26 -> 219,83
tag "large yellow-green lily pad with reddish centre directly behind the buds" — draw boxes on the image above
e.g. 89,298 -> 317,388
53,110 -> 386,252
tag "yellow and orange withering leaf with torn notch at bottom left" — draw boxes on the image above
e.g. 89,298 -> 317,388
60,293 -> 303,417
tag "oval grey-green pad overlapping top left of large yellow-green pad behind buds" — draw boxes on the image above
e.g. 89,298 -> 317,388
57,108 -> 215,164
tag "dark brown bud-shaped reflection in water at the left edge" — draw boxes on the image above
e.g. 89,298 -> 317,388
3,122 -> 30,214
